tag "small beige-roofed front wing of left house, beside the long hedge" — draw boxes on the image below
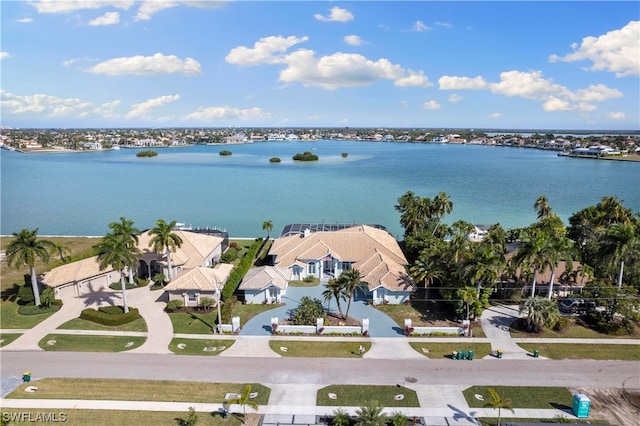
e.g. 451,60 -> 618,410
164,263 -> 233,306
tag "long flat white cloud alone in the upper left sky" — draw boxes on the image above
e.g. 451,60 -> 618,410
89,53 -> 201,75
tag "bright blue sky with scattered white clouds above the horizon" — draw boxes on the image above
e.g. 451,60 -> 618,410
0,0 -> 640,130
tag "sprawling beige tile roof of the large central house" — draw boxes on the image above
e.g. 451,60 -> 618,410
269,225 -> 412,291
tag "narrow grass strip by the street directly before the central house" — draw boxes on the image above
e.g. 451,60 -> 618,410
269,337 -> 371,358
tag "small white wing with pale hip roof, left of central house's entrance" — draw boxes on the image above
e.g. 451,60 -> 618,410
238,265 -> 291,304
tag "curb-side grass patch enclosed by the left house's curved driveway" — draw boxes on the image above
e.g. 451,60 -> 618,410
38,334 -> 147,352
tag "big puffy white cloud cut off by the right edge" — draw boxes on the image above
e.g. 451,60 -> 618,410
549,21 -> 640,77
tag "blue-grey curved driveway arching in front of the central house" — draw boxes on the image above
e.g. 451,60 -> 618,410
240,283 -> 404,337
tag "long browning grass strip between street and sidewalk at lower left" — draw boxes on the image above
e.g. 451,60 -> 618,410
6,378 -> 271,404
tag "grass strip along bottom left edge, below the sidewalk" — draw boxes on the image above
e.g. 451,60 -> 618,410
2,408 -> 243,426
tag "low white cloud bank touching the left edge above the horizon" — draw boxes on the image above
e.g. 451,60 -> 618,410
0,90 -> 120,118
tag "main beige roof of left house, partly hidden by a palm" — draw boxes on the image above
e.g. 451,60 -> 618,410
138,231 -> 223,269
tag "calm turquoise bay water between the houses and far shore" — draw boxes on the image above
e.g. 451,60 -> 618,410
0,141 -> 640,237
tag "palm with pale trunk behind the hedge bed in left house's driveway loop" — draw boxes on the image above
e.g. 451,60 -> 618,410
95,233 -> 140,313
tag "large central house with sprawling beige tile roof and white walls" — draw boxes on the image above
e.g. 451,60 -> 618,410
262,225 -> 414,304
